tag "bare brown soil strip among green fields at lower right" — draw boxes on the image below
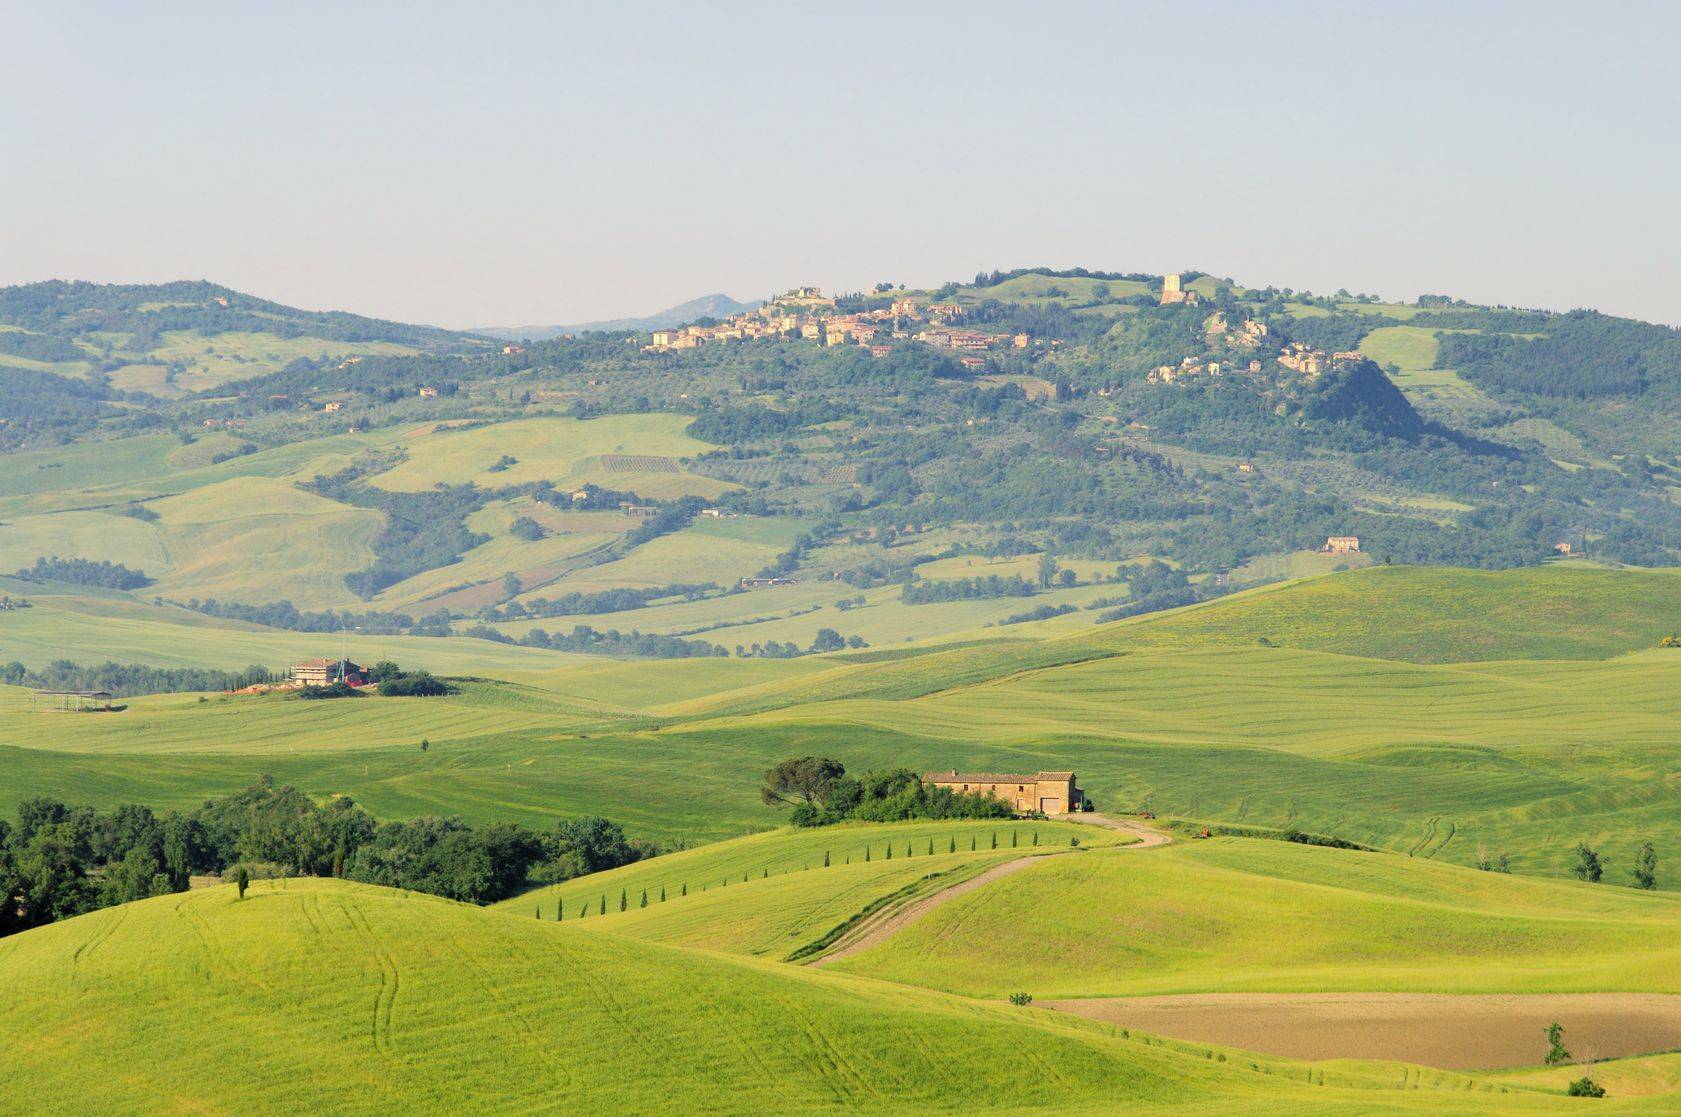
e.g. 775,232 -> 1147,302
1039,993 -> 1681,1070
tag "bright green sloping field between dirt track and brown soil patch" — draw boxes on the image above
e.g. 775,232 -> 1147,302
835,838 -> 1681,998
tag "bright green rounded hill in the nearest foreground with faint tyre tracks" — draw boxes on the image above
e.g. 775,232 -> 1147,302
0,880 -> 1654,1115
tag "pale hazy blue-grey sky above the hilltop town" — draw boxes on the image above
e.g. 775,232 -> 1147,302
0,0 -> 1681,326
